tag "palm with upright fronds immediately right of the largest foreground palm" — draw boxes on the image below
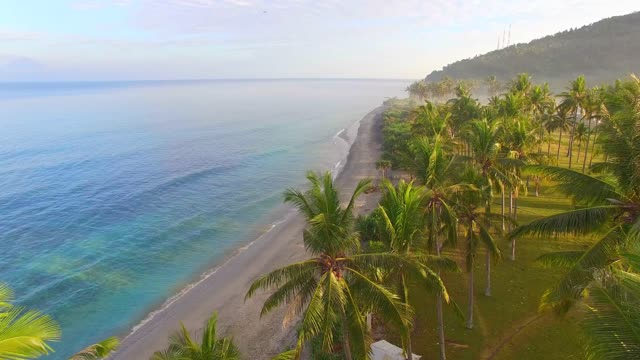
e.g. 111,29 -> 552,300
378,180 -> 457,360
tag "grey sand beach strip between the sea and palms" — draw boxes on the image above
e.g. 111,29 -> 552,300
112,106 -> 384,360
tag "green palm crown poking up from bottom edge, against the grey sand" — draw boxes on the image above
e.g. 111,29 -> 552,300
150,313 -> 240,360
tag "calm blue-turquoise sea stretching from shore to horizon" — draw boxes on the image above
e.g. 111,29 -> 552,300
0,80 -> 407,359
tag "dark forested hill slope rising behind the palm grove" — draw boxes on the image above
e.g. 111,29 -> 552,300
426,12 -> 640,86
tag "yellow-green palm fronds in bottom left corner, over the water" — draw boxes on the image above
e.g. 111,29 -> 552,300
0,283 -> 60,360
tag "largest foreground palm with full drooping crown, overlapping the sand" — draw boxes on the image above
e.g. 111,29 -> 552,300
247,172 -> 410,360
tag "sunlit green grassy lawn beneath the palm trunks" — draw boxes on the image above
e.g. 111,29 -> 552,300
394,134 -> 589,360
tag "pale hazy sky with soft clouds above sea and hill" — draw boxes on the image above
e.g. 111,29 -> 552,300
0,0 -> 640,81
